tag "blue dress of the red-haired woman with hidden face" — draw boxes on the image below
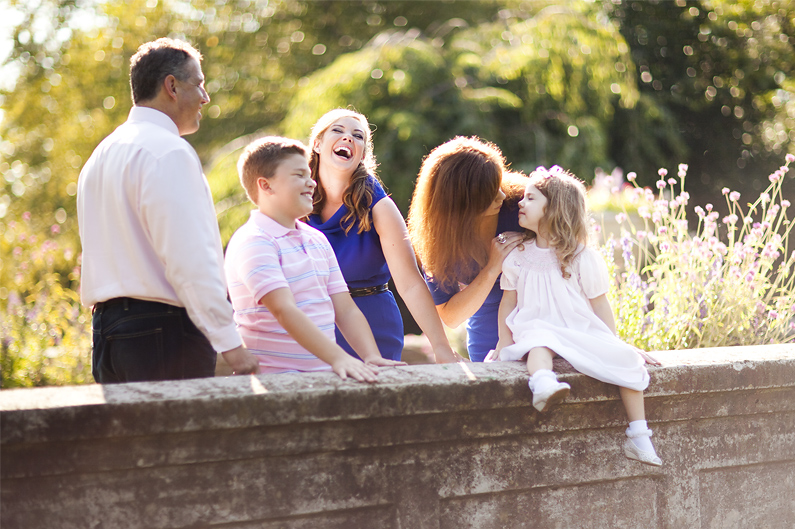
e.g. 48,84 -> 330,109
425,199 -> 524,362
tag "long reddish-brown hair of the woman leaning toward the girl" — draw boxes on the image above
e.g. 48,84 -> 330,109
407,136 -> 526,289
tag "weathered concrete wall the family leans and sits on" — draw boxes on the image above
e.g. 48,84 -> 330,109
0,345 -> 795,529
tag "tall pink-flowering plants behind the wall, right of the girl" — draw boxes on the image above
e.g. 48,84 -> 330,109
602,154 -> 795,351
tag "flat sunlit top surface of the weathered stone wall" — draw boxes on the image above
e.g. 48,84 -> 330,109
0,344 -> 795,412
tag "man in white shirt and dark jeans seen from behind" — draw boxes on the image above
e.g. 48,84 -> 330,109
77,38 -> 259,383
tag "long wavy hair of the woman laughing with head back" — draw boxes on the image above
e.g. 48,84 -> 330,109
309,108 -> 384,234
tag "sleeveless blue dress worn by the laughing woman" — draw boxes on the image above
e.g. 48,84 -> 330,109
309,176 -> 403,360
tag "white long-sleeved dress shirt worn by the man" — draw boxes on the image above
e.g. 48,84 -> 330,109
77,106 -> 242,352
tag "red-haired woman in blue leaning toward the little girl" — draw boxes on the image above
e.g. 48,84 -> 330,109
408,137 -> 527,362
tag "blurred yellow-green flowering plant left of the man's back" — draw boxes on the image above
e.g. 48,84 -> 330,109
0,213 -> 92,388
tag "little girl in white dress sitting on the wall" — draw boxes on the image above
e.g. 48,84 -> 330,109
490,166 -> 662,466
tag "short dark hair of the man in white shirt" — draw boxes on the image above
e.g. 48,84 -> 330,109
130,37 -> 202,105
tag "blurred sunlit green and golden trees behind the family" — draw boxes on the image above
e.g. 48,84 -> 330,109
0,0 -> 795,387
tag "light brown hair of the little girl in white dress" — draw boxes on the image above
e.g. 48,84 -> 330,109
528,165 -> 588,278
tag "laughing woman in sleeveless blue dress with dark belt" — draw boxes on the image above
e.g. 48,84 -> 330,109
308,109 -> 461,362
